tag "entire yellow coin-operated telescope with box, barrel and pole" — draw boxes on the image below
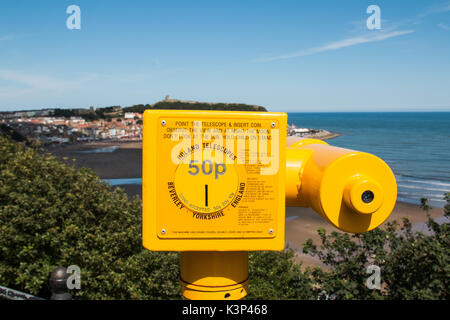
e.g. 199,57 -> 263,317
142,110 -> 397,300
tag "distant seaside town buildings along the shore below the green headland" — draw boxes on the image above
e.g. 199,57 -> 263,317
0,100 -> 339,144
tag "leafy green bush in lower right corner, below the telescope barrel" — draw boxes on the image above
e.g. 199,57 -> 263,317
304,194 -> 450,300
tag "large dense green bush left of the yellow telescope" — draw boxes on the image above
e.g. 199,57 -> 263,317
0,135 -> 180,299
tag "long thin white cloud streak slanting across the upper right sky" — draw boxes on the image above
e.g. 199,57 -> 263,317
255,30 -> 414,62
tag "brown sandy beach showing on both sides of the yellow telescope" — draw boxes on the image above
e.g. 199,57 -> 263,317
47,139 -> 444,266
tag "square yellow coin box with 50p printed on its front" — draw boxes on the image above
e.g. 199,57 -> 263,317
142,110 -> 287,251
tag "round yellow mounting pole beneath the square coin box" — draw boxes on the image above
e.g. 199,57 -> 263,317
180,251 -> 248,300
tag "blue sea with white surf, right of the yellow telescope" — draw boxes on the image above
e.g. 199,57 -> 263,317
288,112 -> 450,208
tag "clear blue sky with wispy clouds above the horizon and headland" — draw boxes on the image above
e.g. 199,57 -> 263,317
0,0 -> 450,112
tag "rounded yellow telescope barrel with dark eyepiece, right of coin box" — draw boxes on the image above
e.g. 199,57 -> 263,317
286,139 -> 397,233
